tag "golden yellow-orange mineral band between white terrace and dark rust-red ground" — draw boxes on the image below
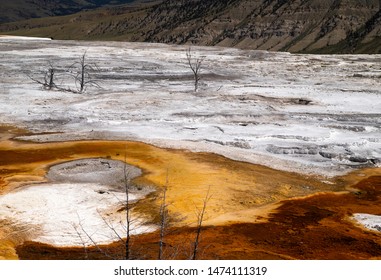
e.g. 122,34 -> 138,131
0,127 -> 381,259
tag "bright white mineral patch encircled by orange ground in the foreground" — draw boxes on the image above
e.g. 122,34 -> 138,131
0,183 -> 155,246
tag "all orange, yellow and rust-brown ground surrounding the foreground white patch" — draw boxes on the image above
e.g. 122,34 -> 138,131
0,127 -> 381,259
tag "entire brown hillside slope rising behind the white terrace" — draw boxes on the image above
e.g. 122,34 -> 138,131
0,0 -> 381,53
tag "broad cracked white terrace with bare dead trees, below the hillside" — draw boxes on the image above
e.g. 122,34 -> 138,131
0,37 -> 381,176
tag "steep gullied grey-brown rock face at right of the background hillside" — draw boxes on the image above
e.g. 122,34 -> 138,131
140,0 -> 380,52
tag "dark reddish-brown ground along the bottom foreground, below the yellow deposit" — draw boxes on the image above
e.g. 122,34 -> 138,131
17,176 -> 381,259
